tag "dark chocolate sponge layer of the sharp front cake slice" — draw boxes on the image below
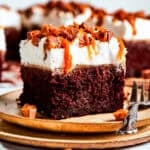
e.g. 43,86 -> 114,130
20,65 -> 124,119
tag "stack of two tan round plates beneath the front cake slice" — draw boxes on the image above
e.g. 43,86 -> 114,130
0,85 -> 150,149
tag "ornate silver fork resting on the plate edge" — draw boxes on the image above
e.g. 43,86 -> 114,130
118,81 -> 150,134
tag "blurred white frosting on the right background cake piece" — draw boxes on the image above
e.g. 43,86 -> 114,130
103,16 -> 150,40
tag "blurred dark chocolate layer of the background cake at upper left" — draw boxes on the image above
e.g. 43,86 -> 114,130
5,27 -> 21,60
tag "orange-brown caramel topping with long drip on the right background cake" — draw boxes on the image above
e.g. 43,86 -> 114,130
113,10 -> 145,35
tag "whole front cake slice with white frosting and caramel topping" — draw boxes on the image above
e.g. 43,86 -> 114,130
20,24 -> 126,119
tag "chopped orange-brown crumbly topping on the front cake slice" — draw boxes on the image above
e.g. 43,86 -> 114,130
27,24 -> 113,49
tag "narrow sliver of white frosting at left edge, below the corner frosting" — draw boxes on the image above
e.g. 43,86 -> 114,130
0,27 -> 6,51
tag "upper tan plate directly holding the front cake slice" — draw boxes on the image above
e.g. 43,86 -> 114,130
0,88 -> 150,133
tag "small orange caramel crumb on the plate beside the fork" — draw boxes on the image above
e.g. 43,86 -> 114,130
113,109 -> 128,120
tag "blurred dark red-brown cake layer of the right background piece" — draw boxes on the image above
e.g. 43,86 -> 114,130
125,40 -> 150,77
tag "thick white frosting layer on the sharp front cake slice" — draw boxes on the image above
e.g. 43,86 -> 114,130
20,34 -> 126,71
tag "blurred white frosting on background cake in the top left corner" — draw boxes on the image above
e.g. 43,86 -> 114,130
0,7 -> 21,29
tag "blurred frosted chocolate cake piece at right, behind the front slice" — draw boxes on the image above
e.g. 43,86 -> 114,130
88,9 -> 150,77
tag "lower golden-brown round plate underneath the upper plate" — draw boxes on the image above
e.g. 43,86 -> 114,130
0,120 -> 150,149
